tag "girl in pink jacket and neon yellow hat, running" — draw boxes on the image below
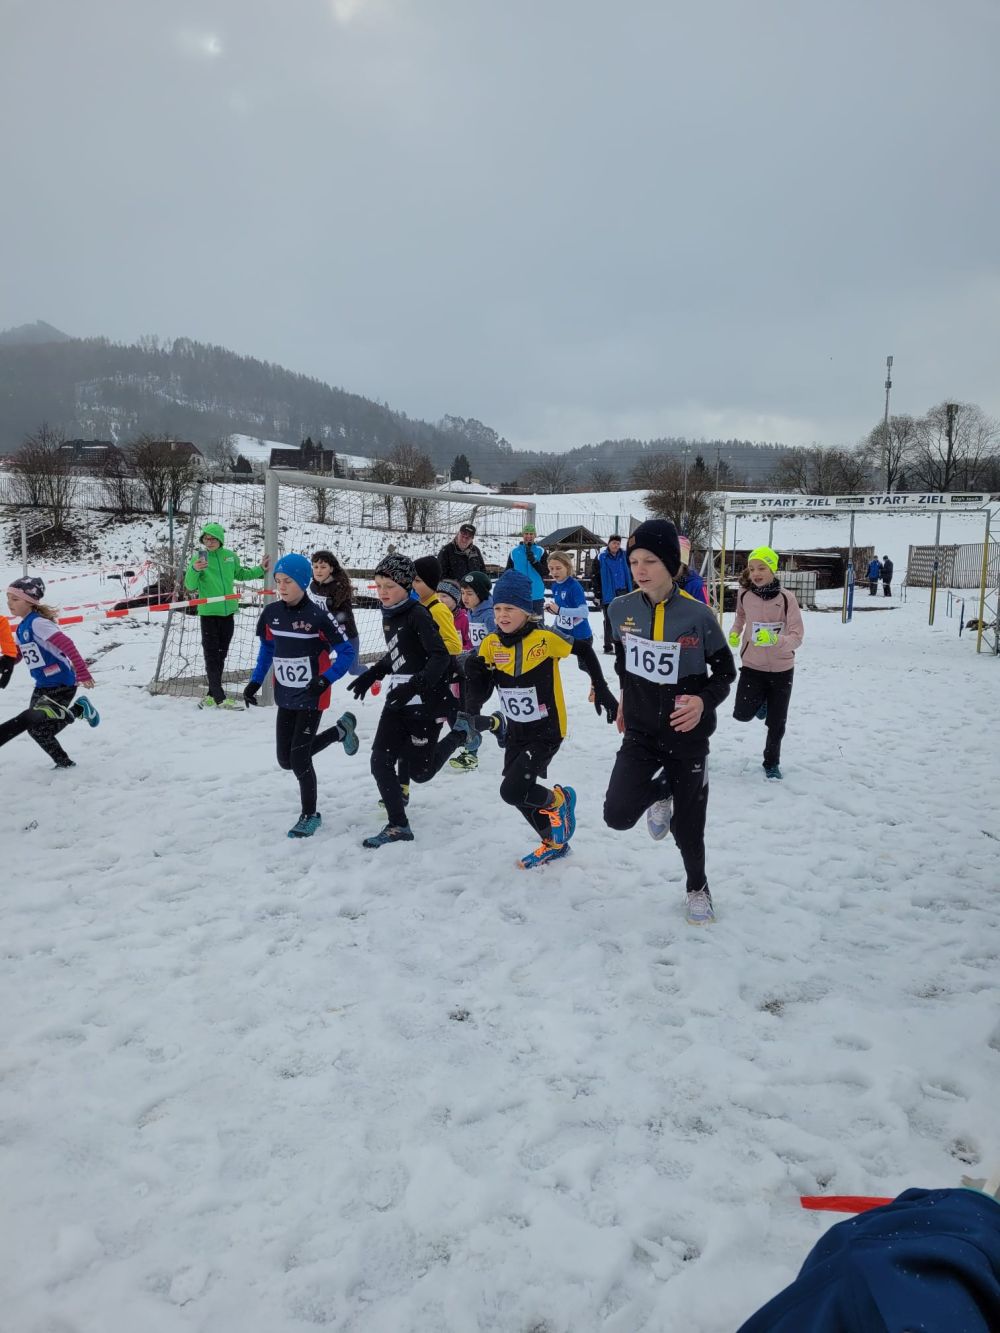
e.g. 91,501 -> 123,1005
729,547 -> 805,780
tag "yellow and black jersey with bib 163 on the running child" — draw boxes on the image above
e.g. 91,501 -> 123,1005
479,628 -> 573,741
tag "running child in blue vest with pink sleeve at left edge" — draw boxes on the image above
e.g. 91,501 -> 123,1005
0,577 -> 100,768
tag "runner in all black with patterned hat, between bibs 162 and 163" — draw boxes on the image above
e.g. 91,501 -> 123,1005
348,555 -> 455,848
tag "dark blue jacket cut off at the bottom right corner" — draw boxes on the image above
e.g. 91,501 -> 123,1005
739,1189 -> 1000,1333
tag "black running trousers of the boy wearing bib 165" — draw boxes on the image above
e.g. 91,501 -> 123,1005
604,732 -> 708,893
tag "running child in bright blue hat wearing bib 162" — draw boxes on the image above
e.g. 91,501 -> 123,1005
243,555 -> 359,837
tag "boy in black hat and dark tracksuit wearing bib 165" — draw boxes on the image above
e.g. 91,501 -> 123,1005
604,519 -> 736,925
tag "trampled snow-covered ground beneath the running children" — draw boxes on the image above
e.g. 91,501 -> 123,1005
0,554 -> 1000,1333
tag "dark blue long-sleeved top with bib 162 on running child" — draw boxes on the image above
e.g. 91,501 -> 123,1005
251,593 -> 355,708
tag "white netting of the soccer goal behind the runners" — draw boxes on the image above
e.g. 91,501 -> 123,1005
149,469 -> 535,696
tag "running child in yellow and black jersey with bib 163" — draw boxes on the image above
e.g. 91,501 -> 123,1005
461,569 -> 617,870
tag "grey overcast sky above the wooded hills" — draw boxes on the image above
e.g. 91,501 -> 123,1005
0,0 -> 1000,448
